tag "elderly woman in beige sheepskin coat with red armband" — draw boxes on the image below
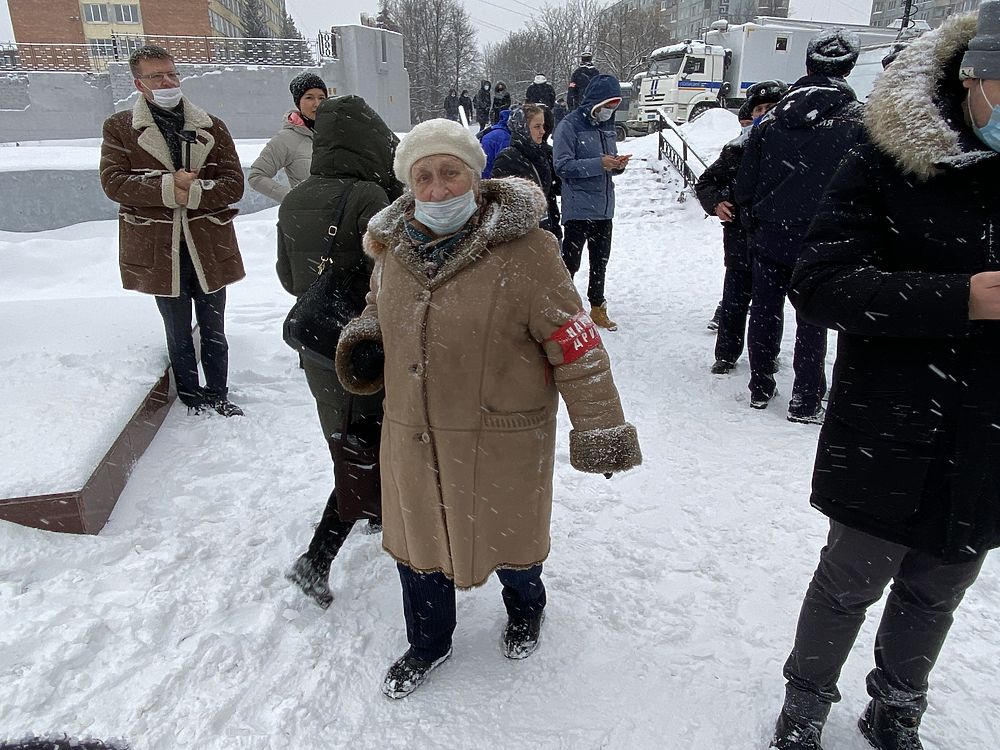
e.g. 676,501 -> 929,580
337,120 -> 642,698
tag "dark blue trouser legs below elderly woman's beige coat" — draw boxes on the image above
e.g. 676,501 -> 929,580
396,563 -> 545,661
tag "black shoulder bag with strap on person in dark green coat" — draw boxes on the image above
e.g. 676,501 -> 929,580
282,181 -> 367,370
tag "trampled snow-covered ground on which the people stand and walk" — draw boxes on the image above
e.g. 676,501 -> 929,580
0,135 -> 1000,750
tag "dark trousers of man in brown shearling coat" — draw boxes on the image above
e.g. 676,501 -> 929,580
156,243 -> 229,406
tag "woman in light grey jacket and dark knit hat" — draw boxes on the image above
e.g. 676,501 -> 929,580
249,72 -> 327,203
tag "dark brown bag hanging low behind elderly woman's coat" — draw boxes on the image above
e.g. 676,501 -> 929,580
328,395 -> 382,521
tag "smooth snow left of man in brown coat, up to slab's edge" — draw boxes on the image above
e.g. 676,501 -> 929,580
0,222 -> 167,497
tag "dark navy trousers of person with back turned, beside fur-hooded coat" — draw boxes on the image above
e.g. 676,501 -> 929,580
747,254 -> 826,413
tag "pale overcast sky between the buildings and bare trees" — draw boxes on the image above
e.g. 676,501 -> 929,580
0,0 -> 871,44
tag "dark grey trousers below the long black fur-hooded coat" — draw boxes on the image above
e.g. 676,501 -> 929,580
784,521 -> 985,724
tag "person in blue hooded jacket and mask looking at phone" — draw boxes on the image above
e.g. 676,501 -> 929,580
552,75 -> 632,331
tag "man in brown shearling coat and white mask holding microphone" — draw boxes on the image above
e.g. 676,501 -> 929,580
101,46 -> 246,417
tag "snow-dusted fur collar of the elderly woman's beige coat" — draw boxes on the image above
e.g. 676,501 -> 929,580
364,177 -> 548,286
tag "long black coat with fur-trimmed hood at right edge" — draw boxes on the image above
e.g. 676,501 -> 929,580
790,15 -> 1000,560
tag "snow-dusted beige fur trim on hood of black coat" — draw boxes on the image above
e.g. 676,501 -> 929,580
865,13 -> 996,181
